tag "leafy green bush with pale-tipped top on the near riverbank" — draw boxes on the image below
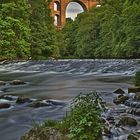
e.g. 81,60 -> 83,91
65,93 -> 103,140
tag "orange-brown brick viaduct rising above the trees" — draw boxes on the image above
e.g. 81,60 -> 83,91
50,0 -> 98,27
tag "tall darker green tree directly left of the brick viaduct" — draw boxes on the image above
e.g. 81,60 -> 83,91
30,0 -> 59,59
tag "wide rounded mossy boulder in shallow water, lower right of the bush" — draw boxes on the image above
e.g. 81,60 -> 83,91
118,116 -> 138,126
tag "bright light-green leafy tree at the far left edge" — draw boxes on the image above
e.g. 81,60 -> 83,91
0,0 -> 30,60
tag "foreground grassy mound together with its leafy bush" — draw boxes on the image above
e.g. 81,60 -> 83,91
21,92 -> 103,140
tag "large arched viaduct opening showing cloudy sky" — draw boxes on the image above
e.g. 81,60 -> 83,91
66,1 -> 87,20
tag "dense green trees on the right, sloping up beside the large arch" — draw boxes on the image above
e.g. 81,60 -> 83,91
62,0 -> 140,58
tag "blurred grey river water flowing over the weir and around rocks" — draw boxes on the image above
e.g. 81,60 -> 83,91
0,60 -> 140,140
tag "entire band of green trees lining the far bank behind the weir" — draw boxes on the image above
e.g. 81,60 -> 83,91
0,0 -> 140,60
